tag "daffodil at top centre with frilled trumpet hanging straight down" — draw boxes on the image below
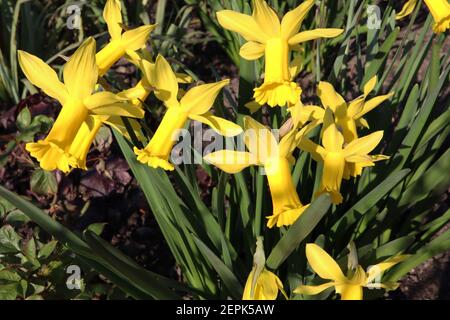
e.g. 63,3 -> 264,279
217,0 -> 343,107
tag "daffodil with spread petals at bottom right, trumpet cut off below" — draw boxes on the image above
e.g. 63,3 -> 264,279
294,243 -> 407,300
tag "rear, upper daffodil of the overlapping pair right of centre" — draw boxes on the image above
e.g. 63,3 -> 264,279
316,76 -> 393,143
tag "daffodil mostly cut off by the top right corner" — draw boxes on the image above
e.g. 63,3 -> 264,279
396,0 -> 450,33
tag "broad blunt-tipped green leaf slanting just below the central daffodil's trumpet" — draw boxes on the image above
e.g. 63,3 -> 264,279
266,194 -> 331,270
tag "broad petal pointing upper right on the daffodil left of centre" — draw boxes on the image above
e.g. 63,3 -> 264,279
180,79 -> 230,115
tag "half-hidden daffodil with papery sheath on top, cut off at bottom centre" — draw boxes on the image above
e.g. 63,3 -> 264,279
242,237 -> 287,300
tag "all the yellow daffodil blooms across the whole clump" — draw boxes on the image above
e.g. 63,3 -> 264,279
18,0 -> 424,299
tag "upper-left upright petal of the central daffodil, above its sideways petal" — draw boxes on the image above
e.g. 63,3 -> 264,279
244,116 -> 278,163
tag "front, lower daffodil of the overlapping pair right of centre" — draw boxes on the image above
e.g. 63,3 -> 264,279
299,109 -> 388,204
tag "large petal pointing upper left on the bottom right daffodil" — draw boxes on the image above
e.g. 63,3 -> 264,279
306,243 -> 347,283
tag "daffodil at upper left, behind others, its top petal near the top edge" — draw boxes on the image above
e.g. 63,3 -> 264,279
96,0 -> 155,76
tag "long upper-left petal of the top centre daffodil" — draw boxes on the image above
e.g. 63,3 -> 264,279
217,10 -> 266,43
